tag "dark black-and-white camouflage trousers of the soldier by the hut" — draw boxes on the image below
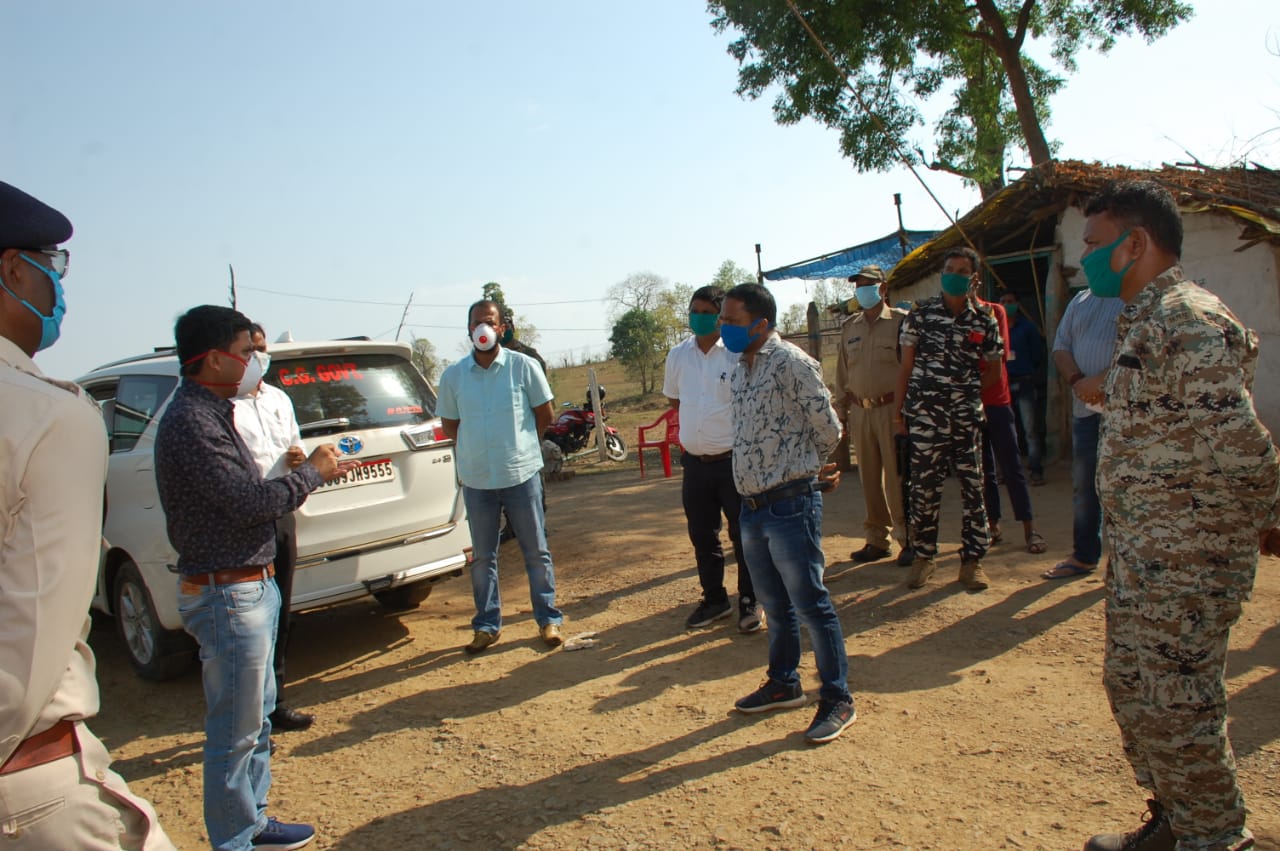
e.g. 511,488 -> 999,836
910,411 -> 988,562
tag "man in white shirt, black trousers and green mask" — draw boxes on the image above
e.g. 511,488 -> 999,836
662,287 -> 760,632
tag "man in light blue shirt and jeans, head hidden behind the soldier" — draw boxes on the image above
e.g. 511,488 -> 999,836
1043,289 -> 1124,580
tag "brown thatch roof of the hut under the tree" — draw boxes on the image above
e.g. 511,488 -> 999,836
888,160 -> 1280,288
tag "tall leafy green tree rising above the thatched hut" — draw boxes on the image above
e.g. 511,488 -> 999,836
708,0 -> 1192,197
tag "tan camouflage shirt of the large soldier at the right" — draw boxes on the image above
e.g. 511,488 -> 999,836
1097,266 -> 1280,600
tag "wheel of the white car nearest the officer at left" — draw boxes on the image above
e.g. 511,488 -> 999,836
111,562 -> 196,681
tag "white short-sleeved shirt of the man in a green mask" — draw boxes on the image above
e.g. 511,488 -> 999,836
662,337 -> 739,456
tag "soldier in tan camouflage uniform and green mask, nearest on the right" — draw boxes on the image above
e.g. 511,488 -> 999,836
1083,182 -> 1280,851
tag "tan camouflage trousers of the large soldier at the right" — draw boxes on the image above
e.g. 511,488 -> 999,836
1102,588 -> 1248,851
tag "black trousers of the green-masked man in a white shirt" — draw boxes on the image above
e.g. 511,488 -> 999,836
680,452 -> 755,603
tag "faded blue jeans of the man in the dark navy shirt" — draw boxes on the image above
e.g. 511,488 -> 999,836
178,578 -> 280,851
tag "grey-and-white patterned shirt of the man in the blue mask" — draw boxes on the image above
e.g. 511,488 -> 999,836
730,334 -> 840,497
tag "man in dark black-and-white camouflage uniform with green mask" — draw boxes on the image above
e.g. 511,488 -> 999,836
893,248 -> 1005,591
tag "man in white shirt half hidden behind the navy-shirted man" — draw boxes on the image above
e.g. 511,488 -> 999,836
233,322 -> 316,731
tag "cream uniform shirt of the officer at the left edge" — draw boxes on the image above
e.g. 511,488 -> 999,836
0,337 -> 106,763
